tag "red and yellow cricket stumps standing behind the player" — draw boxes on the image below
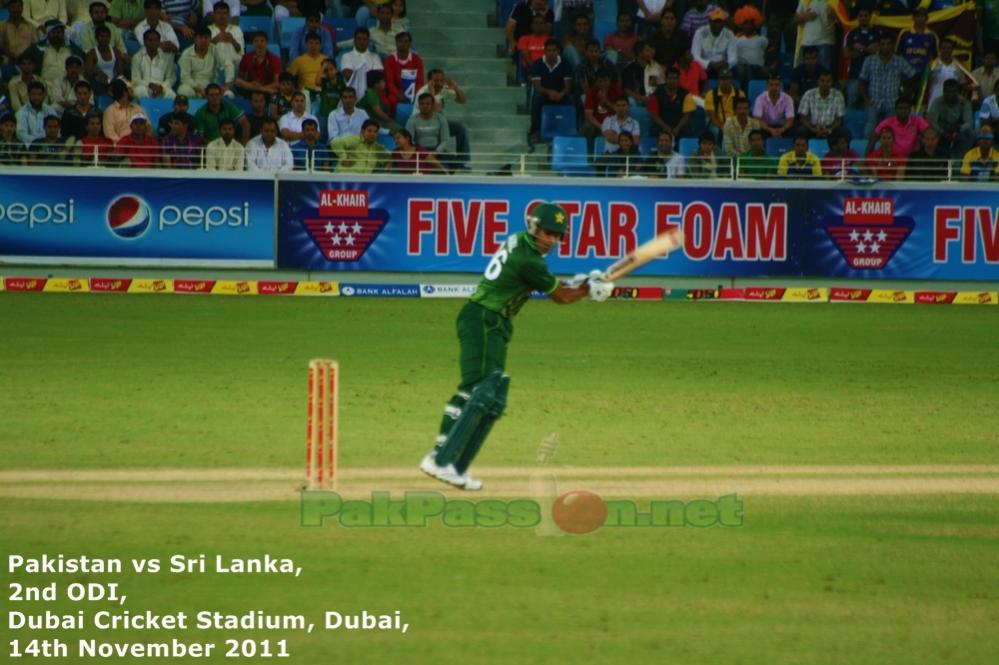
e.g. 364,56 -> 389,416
305,358 -> 340,490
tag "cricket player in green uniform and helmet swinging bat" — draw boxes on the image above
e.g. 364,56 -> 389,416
420,203 -> 614,490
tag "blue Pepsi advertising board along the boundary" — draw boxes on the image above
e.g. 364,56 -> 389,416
0,173 -> 274,268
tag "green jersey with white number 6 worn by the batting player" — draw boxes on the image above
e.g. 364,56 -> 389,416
471,231 -> 558,319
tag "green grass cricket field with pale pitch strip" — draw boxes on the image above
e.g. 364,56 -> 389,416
0,293 -> 999,665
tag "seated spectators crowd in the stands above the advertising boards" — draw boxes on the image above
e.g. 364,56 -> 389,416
0,0 -> 999,180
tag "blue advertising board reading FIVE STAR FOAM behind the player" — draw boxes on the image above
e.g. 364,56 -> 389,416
277,177 -> 999,280
